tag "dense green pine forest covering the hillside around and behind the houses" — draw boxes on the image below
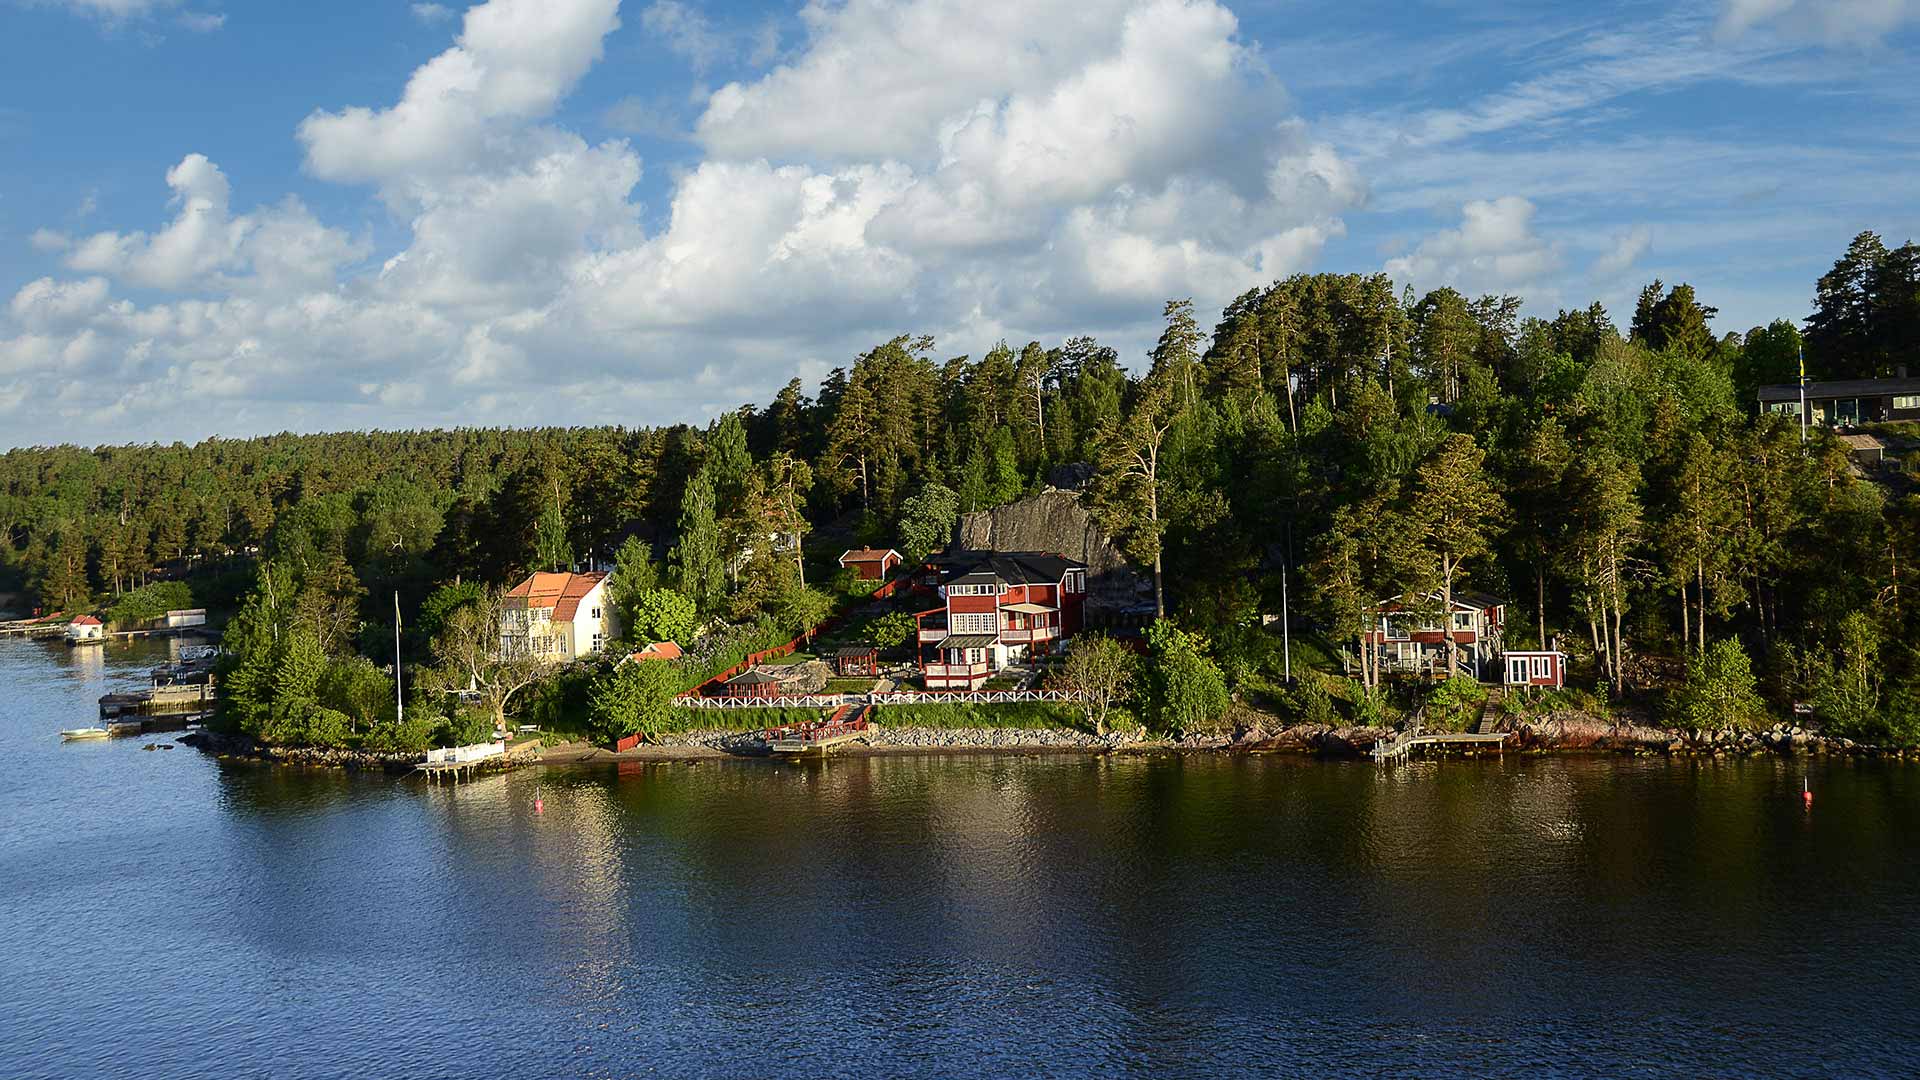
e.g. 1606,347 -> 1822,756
0,233 -> 1920,746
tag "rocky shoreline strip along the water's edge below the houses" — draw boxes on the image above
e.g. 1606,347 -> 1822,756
180,713 -> 1920,773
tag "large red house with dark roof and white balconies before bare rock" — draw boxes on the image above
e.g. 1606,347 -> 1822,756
914,552 -> 1087,690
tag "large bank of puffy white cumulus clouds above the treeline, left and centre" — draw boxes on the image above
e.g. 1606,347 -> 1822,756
0,0 -> 1382,441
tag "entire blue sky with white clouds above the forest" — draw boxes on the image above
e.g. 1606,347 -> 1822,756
0,0 -> 1920,446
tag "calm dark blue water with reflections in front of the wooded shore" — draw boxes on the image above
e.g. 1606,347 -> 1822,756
0,642 -> 1920,1078
